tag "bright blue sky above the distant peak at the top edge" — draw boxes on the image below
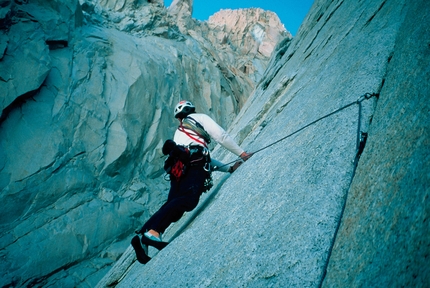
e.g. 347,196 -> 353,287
164,0 -> 314,36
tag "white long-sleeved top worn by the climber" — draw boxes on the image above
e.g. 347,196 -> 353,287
173,113 -> 244,172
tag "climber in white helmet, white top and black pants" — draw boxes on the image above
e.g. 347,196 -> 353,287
131,101 -> 252,264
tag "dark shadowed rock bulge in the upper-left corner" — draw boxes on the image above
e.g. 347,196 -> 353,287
0,0 -> 82,114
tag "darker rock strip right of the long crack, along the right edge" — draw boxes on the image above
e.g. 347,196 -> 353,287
323,1 -> 430,287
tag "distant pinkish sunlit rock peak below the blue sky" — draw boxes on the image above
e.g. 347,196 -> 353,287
203,9 -> 292,88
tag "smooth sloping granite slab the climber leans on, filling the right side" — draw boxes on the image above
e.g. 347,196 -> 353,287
99,0 -> 430,287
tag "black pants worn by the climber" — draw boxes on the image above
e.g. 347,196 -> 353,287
139,166 -> 206,234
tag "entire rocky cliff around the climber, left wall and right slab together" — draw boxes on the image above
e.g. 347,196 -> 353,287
0,0 -> 430,287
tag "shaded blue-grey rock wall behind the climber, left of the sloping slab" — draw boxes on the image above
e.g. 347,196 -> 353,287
0,0 -> 288,287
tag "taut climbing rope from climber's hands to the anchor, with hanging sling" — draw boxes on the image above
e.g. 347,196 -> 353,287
218,93 -> 379,168
